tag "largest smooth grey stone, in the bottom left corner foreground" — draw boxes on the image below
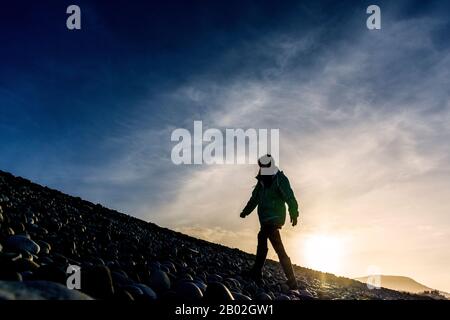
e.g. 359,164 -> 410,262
0,281 -> 92,300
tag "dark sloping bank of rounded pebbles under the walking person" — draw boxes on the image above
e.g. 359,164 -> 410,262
0,171 -> 430,301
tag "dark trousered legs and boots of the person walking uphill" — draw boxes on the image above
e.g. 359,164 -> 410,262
252,225 -> 297,286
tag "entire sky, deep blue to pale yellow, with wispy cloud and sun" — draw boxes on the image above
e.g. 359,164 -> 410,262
0,1 -> 450,292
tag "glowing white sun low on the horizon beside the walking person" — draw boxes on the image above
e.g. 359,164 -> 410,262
304,234 -> 343,273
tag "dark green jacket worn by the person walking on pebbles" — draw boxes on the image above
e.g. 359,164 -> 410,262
242,171 -> 298,226
